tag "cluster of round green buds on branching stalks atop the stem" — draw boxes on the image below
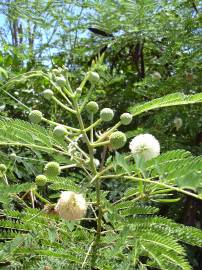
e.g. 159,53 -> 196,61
29,68 -> 132,194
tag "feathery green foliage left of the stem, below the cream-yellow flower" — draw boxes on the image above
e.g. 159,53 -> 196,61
0,208 -> 92,269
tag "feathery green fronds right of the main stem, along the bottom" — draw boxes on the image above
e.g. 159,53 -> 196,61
99,201 -> 202,270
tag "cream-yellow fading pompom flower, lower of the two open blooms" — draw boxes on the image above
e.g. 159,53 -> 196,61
55,191 -> 87,220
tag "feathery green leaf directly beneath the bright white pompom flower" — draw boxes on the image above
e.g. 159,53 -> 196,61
111,149 -> 202,198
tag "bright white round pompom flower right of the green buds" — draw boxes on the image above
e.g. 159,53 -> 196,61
129,134 -> 160,161
